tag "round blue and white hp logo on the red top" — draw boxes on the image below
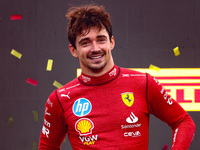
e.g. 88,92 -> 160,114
73,98 -> 92,117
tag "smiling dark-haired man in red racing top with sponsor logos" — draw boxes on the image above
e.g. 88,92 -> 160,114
39,5 -> 195,150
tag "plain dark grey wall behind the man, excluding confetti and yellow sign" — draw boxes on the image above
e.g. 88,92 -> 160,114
0,0 -> 200,150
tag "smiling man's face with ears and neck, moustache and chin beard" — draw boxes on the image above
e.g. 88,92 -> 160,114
69,27 -> 115,76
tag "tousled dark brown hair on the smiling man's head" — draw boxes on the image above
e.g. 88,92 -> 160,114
66,4 -> 112,48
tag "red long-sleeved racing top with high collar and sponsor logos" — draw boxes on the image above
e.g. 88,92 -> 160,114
39,65 -> 195,150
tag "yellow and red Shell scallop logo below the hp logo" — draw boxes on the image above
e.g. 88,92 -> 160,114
75,118 -> 94,136
